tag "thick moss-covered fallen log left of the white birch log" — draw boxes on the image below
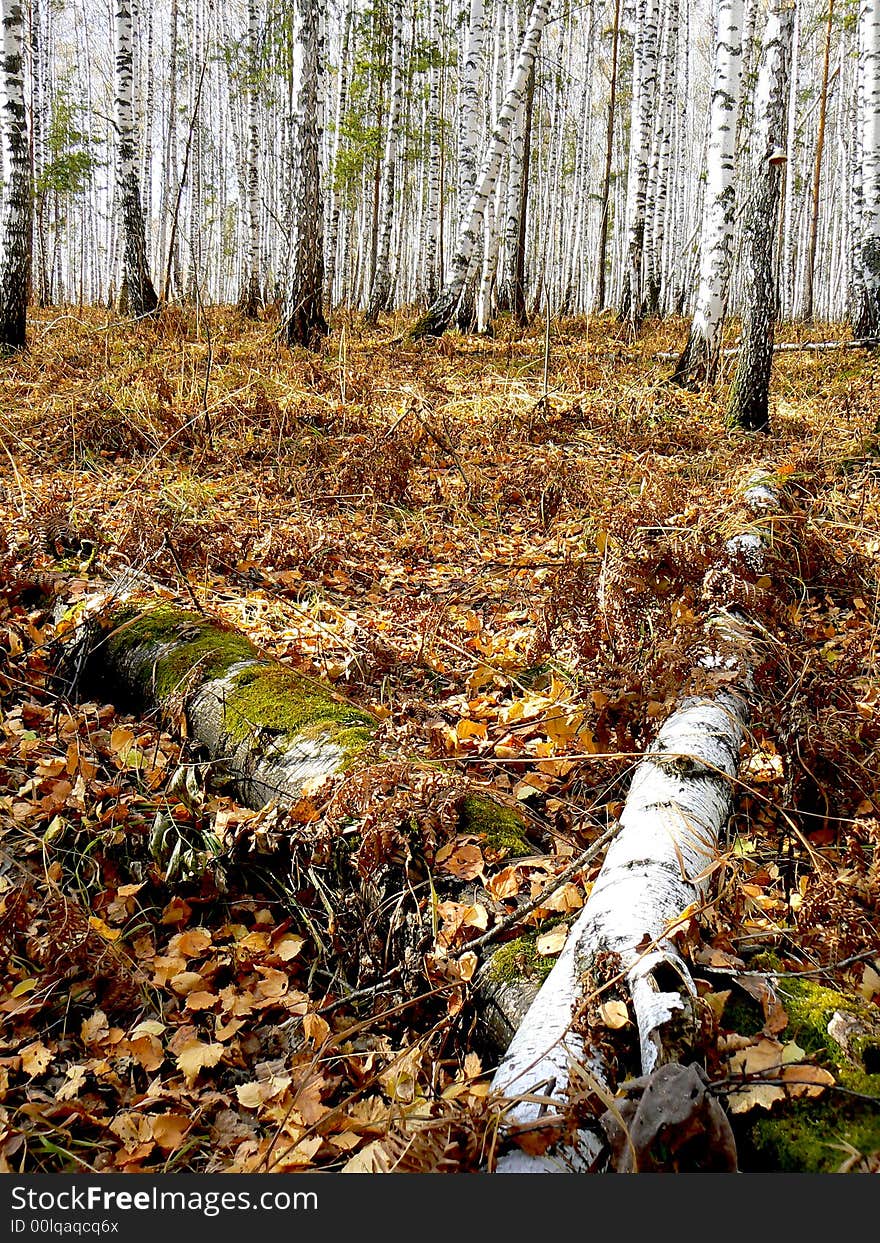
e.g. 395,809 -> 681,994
70,598 -> 546,1052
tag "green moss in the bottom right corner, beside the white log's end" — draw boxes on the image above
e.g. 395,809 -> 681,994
747,977 -> 880,1173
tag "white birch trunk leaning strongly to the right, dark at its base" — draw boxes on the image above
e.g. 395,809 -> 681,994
410,0 -> 549,339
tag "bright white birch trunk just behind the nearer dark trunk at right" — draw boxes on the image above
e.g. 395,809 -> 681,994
672,0 -> 743,384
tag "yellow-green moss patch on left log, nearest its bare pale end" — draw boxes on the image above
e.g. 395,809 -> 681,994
225,663 -> 378,759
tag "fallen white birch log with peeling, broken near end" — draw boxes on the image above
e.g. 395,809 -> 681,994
492,482 -> 778,1172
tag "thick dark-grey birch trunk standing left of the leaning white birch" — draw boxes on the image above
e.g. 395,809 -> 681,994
282,0 -> 328,349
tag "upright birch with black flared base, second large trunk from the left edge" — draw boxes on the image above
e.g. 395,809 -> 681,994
114,0 -> 158,319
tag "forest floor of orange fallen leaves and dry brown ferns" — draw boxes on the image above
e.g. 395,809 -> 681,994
0,310 -> 880,1172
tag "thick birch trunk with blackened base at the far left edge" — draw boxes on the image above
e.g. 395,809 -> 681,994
0,0 -> 34,351
